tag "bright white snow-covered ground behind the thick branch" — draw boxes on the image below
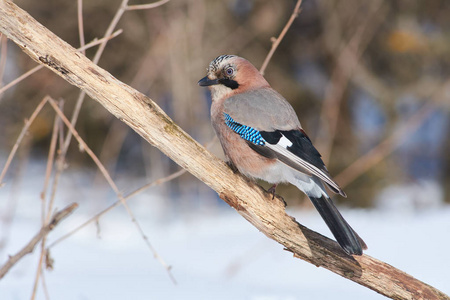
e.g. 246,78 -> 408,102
0,165 -> 450,300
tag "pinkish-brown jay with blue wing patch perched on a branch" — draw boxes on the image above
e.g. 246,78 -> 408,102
198,55 -> 367,255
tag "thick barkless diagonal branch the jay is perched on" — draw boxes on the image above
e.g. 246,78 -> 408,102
0,1 -> 450,299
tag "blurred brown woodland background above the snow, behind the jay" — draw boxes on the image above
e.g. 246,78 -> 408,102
0,0 -> 450,299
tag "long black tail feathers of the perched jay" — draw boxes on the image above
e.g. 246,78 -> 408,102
309,196 -> 367,255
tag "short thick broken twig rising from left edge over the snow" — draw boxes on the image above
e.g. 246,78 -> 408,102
0,203 -> 78,279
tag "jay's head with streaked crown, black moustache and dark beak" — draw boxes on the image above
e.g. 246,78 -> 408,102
198,55 -> 269,101
